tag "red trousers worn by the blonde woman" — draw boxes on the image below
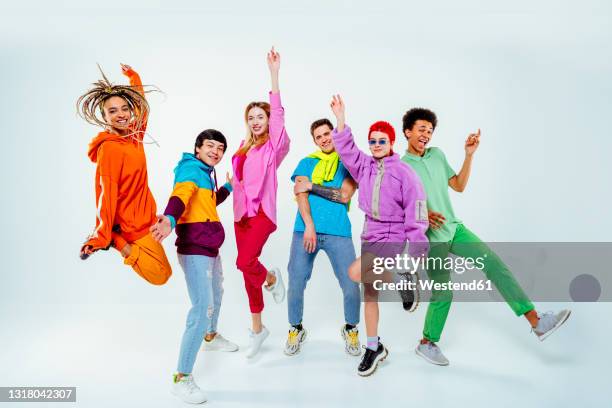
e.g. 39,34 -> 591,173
234,208 -> 276,313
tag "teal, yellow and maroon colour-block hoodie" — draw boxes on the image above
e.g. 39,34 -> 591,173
164,153 -> 232,256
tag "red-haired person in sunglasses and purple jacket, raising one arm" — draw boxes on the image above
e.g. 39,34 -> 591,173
331,95 -> 428,376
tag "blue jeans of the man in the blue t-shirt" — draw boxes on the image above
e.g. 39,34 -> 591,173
287,232 -> 361,325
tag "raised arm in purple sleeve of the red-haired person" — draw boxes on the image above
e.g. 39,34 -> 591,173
331,95 -> 371,182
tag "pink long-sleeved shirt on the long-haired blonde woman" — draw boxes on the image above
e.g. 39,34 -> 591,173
232,92 -> 290,224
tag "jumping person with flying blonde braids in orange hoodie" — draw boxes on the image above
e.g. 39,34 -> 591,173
77,64 -> 172,285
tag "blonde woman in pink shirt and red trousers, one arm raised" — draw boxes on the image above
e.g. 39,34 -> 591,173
232,48 -> 289,358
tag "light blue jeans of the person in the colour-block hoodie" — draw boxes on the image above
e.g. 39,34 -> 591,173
177,254 -> 223,374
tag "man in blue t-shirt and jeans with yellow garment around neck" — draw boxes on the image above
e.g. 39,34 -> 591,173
285,119 -> 361,356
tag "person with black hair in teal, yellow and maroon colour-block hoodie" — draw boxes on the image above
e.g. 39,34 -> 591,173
151,129 -> 238,403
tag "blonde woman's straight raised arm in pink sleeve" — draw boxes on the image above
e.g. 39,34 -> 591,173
267,47 -> 290,165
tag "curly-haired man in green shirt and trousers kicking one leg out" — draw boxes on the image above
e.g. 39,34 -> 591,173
402,108 -> 570,365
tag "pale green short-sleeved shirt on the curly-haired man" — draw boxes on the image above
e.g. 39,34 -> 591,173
402,147 -> 461,242
